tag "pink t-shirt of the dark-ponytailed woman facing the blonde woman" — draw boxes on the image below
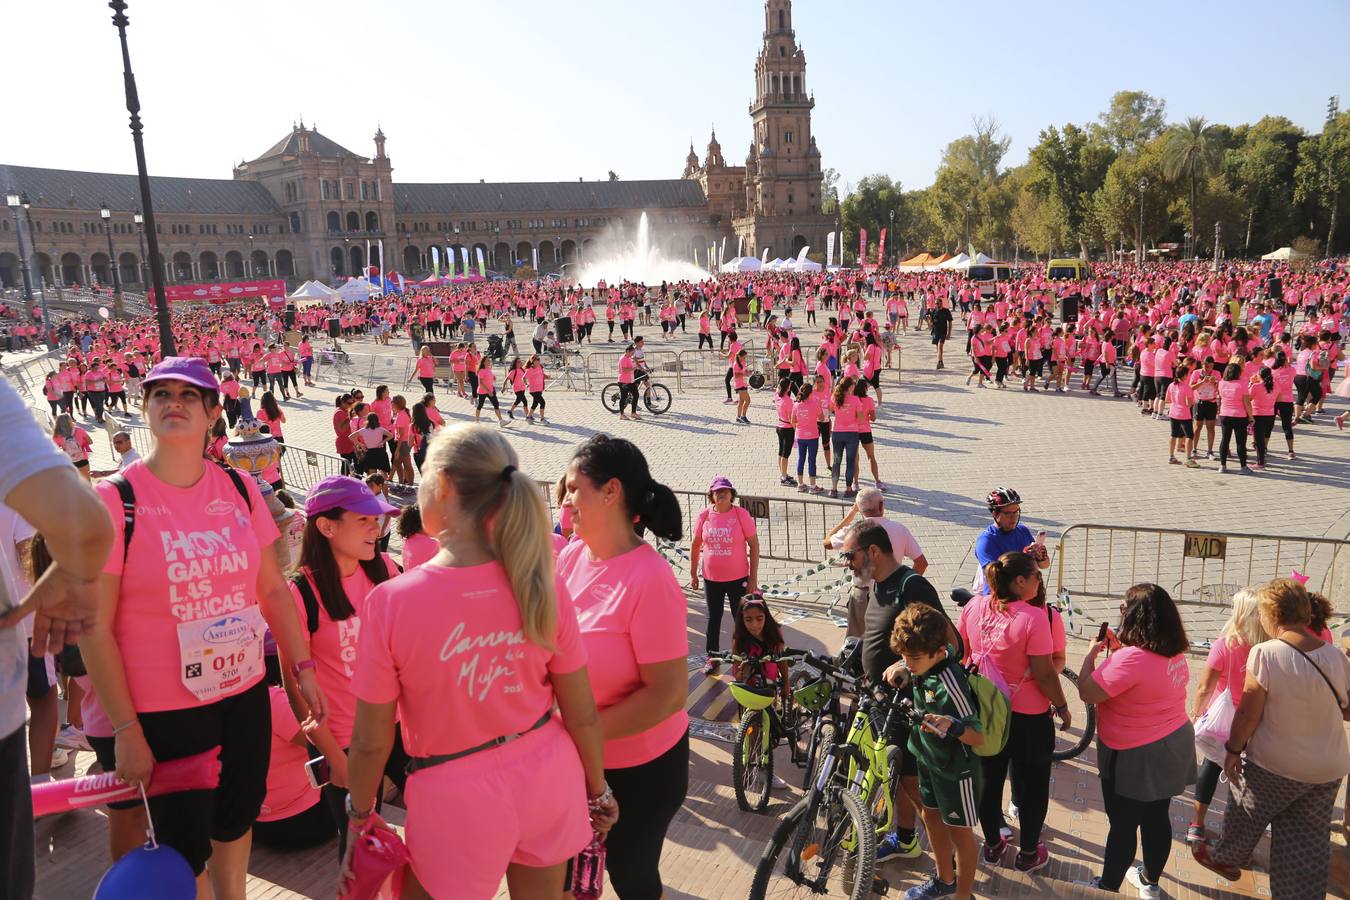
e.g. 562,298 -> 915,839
558,541 -> 689,769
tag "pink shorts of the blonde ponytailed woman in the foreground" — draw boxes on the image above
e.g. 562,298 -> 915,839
405,719 -> 591,900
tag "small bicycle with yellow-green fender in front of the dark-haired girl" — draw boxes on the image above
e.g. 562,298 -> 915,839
707,650 -> 806,812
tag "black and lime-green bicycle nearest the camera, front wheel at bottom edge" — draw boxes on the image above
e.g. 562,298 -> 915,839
751,653 -> 917,900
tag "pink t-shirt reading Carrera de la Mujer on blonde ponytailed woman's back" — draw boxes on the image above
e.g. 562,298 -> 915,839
352,551 -> 583,756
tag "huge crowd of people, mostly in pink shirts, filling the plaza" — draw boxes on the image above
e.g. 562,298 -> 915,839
0,255 -> 1350,900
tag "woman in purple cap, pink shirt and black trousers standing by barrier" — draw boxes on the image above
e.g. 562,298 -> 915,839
689,475 -> 760,675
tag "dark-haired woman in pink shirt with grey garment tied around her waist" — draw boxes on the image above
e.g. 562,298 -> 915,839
1079,584 -> 1195,896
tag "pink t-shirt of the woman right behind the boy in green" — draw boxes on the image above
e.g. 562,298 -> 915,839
957,594 -> 1054,715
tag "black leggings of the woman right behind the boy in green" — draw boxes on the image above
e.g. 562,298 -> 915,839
980,712 -> 1054,853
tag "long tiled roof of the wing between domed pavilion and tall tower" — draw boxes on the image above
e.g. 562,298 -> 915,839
394,178 -> 706,215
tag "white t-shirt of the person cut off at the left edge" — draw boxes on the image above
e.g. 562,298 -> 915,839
0,378 -> 70,737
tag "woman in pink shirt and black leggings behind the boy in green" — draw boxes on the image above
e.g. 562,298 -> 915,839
957,552 -> 1072,872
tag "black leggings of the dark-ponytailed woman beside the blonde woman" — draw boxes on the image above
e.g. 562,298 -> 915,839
605,734 -> 689,900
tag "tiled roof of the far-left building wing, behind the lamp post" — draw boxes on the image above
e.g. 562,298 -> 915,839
0,163 -> 281,216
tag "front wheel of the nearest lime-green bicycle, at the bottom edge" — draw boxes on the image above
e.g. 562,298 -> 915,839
751,784 -> 876,900
